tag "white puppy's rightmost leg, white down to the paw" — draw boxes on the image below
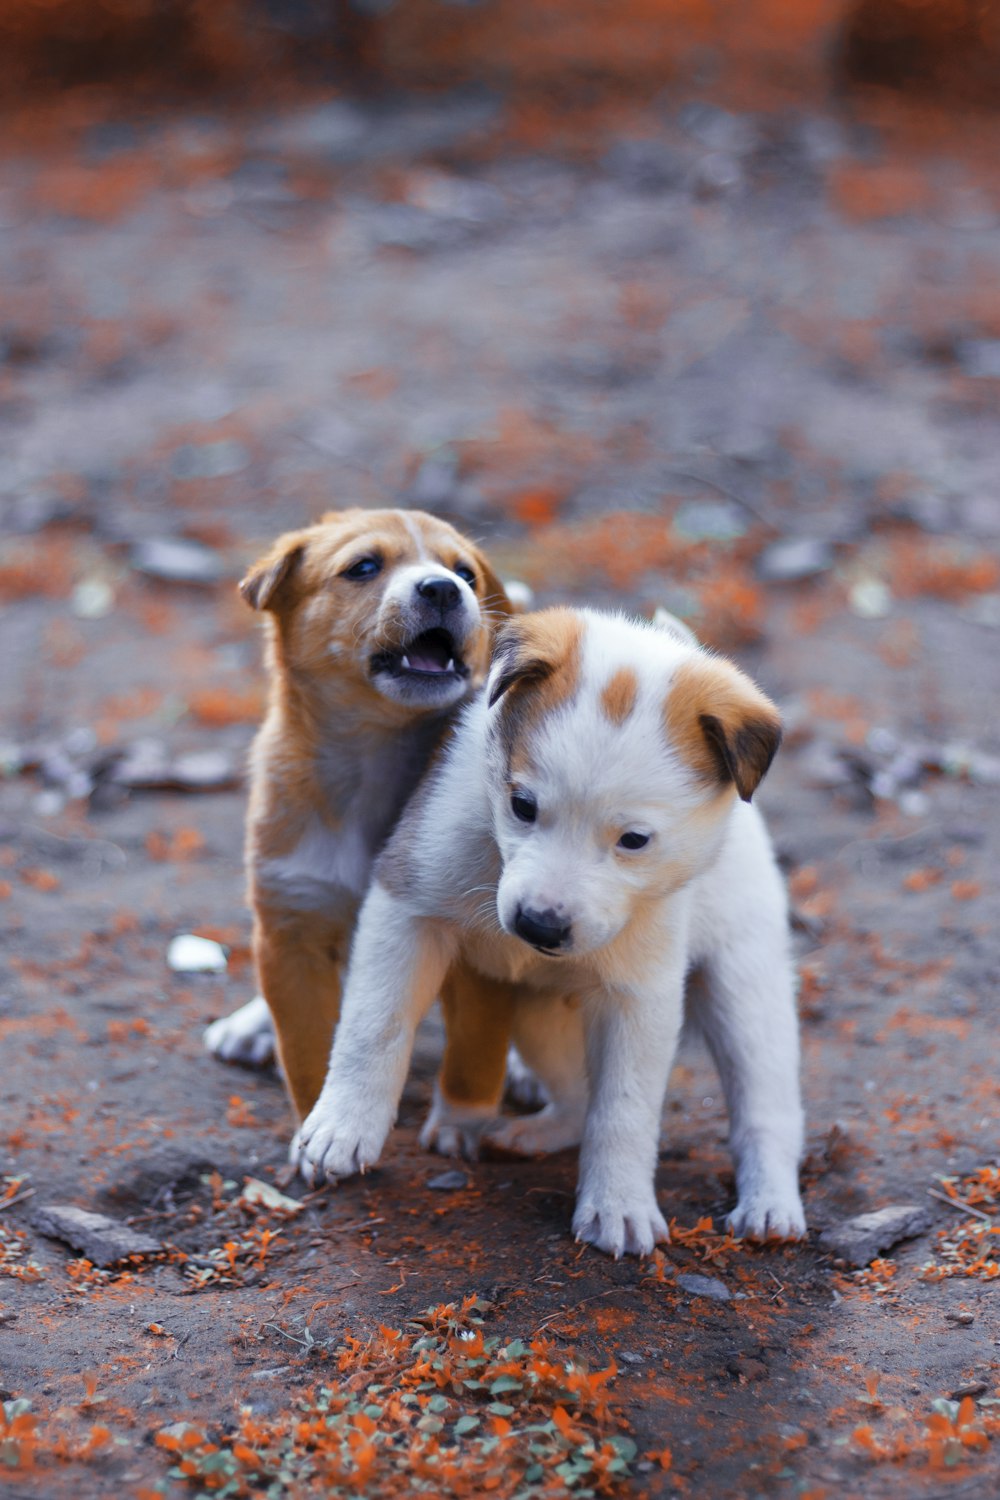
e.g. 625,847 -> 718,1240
691,927 -> 805,1239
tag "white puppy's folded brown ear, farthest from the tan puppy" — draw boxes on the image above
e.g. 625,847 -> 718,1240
664,657 -> 781,803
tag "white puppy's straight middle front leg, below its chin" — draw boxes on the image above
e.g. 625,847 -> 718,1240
573,963 -> 684,1259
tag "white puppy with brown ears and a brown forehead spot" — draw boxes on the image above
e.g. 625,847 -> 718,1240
298,609 -> 805,1256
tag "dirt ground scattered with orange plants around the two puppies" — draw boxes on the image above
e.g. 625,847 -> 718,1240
0,20 -> 1000,1500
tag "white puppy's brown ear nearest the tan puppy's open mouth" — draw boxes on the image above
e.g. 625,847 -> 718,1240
489,609 -> 583,767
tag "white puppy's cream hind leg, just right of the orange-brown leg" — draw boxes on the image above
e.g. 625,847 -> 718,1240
483,995 -> 588,1157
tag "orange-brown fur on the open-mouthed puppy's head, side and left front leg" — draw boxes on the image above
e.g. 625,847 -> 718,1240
240,510 -> 510,1118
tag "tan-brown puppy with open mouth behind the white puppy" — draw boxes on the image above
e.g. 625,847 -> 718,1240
205,510 -> 510,1119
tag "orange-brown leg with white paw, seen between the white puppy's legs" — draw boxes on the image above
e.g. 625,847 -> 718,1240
420,959 -> 517,1161
